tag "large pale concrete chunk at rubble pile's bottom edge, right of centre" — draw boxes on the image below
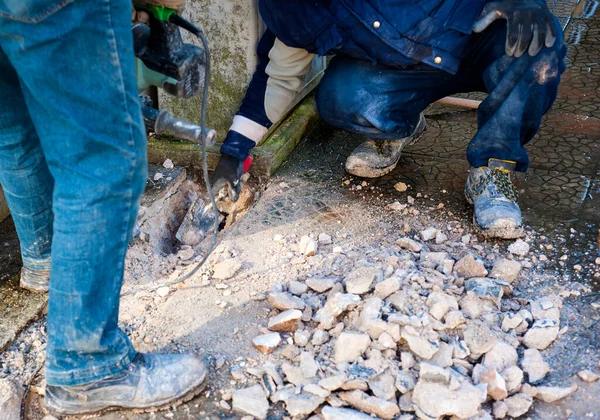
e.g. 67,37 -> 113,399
412,380 -> 487,419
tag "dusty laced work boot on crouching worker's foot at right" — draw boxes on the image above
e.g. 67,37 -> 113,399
465,159 -> 524,239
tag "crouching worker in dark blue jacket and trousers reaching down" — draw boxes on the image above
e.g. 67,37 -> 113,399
213,0 -> 566,239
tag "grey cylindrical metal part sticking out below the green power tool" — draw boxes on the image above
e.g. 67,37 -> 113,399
142,105 -> 217,147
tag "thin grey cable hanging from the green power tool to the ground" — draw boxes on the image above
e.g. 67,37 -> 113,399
121,14 -> 219,296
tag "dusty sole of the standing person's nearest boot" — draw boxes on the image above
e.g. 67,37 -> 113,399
46,374 -> 208,418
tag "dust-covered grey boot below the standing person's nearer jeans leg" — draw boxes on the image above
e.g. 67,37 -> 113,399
45,353 -> 207,415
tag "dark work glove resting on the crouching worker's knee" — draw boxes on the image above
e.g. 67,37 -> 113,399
473,0 -> 557,57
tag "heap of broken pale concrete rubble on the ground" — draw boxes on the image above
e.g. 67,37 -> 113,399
222,228 -> 584,420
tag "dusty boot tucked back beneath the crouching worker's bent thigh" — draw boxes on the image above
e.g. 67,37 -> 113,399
346,113 -> 427,178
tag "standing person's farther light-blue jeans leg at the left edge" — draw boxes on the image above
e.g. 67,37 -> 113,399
0,49 -> 54,271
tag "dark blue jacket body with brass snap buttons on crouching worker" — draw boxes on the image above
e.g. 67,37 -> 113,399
259,0 -> 488,73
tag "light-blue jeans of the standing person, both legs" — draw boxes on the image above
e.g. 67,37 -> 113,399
0,0 -> 147,386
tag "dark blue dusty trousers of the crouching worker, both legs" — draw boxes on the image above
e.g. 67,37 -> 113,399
316,21 -> 566,172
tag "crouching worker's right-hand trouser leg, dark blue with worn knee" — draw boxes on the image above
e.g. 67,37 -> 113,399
463,21 -> 566,172
